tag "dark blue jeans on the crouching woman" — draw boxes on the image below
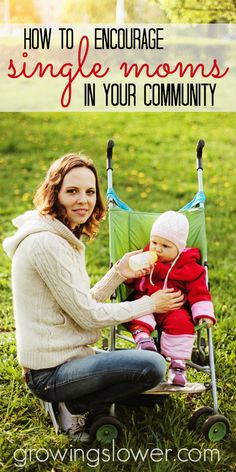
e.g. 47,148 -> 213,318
26,350 -> 165,414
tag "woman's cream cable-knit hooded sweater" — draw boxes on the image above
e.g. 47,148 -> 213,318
3,211 -> 154,369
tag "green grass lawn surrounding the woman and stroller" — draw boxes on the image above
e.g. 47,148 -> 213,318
0,113 -> 236,472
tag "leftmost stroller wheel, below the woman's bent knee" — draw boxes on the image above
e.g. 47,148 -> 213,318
89,416 -> 123,444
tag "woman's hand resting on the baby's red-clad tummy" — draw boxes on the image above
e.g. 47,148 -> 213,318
151,288 -> 184,313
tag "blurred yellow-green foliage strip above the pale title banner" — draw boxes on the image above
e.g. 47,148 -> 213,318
0,0 -> 236,24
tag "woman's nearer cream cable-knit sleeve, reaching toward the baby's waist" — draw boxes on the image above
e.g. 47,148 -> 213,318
28,233 -> 154,329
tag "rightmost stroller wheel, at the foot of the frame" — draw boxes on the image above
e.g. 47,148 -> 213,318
202,415 -> 230,442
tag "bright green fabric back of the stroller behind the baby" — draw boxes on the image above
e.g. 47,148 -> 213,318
109,207 -> 207,301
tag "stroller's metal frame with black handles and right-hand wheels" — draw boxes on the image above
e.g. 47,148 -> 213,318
106,140 -> 230,442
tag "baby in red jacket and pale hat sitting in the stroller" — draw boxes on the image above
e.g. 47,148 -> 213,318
128,211 -> 215,386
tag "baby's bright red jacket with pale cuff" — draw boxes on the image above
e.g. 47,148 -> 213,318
133,244 -> 215,322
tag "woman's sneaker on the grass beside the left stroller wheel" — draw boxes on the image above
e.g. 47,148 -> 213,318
58,402 -> 89,442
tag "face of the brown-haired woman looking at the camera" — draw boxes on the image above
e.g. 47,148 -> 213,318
58,167 -> 96,229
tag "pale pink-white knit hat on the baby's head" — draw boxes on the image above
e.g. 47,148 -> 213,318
151,211 -> 189,254
